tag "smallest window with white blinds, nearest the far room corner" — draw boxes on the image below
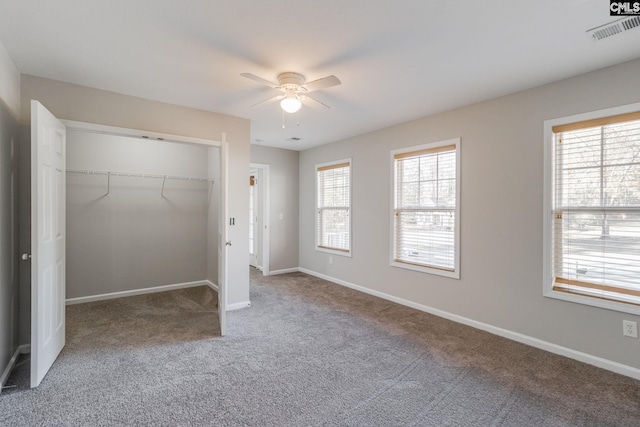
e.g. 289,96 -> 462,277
316,159 -> 351,256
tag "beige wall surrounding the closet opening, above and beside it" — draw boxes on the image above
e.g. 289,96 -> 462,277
21,75 -> 250,342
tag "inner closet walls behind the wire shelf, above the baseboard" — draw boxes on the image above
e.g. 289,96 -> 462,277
66,130 -> 220,299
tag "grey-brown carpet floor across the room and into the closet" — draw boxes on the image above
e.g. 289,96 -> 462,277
0,271 -> 640,426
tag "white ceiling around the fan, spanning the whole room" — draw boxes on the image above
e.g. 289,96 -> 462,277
0,0 -> 640,150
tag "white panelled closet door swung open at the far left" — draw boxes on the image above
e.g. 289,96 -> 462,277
31,101 -> 66,387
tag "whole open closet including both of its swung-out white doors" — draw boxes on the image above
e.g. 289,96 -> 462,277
22,100 -> 231,388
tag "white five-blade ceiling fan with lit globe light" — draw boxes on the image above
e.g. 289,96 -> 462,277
240,71 -> 341,113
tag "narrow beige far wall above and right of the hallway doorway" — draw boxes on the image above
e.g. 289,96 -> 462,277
251,144 -> 300,271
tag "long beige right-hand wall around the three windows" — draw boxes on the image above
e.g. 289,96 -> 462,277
300,60 -> 640,369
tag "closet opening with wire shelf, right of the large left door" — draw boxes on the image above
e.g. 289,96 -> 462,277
65,122 -> 226,346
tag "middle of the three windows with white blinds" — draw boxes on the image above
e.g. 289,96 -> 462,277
391,138 -> 460,279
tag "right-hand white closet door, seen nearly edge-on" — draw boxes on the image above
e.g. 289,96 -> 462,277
218,139 -> 231,336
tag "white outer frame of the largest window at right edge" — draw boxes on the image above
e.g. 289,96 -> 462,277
543,102 -> 640,315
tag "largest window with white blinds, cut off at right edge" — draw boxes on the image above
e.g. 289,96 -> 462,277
545,104 -> 640,313
